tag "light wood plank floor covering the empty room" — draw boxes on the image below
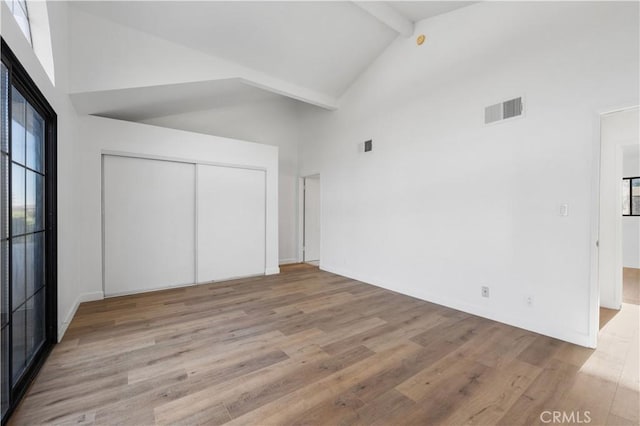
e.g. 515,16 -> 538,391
11,265 -> 639,425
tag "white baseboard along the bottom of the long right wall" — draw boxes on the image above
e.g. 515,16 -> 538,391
320,264 -> 594,348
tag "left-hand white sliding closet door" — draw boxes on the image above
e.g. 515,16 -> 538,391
103,155 -> 195,296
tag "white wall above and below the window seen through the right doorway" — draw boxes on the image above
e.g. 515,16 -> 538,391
622,145 -> 640,268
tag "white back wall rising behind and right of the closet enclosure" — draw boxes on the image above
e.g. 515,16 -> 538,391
143,99 -> 308,263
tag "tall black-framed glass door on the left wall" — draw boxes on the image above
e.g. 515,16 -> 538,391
0,41 -> 57,424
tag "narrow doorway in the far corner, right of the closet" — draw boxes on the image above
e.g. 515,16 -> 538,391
302,175 -> 320,266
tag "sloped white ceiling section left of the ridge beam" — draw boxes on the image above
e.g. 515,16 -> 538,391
72,1 -> 396,97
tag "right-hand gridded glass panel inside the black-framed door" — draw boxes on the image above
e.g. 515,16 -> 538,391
9,82 -> 46,386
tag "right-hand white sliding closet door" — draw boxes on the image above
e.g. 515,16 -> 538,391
197,165 -> 266,282
